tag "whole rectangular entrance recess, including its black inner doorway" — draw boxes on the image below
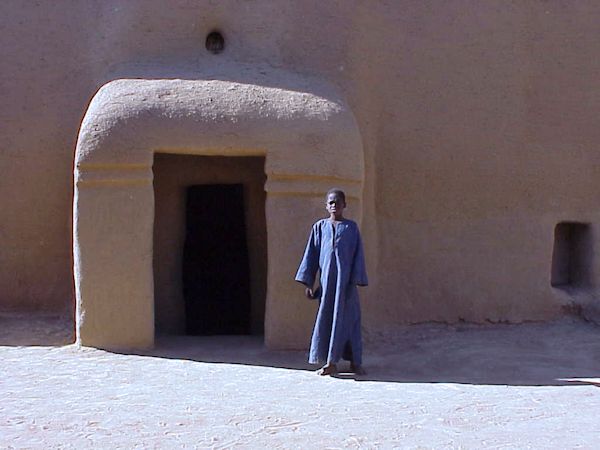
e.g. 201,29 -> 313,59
153,153 -> 267,336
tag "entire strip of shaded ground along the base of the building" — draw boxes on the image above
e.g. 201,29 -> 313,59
0,315 -> 600,386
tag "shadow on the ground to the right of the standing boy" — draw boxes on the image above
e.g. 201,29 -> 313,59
360,317 -> 600,386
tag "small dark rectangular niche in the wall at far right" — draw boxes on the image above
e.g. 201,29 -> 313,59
550,222 -> 594,289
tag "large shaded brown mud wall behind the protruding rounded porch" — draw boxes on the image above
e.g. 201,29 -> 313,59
0,0 -> 600,329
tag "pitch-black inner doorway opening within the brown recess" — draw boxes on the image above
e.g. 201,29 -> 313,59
182,184 -> 251,335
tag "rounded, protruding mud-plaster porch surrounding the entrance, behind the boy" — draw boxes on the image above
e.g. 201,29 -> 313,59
73,74 -> 364,348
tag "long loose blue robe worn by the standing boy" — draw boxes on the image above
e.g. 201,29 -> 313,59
296,219 -> 368,365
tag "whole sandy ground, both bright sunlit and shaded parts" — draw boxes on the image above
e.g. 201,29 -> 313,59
0,316 -> 600,449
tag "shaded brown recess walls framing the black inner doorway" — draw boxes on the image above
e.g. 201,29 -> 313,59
153,153 -> 267,337
